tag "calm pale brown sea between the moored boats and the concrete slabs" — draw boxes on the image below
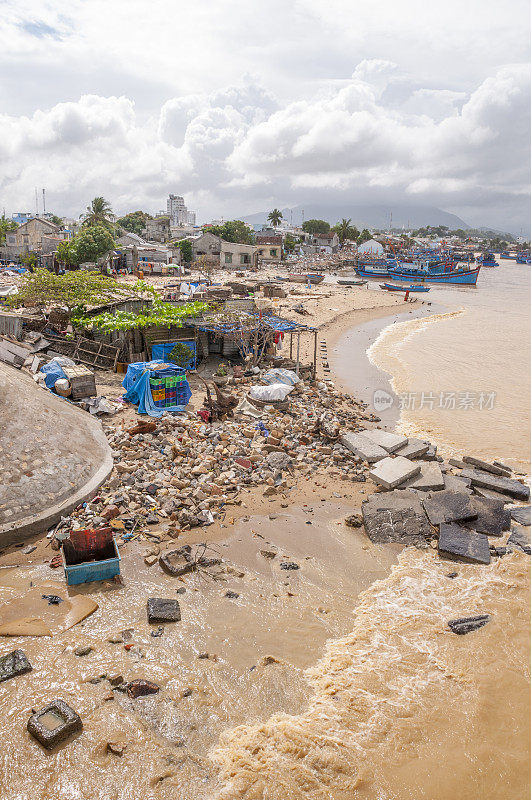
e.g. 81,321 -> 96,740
368,261 -> 531,472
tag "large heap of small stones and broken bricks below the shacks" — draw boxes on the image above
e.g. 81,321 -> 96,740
68,381 -> 380,541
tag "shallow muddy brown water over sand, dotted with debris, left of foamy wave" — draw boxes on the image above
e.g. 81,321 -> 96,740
0,501 -> 398,800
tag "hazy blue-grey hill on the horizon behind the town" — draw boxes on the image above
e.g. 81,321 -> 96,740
243,203 -> 470,230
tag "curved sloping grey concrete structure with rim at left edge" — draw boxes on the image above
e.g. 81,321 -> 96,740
0,363 -> 113,545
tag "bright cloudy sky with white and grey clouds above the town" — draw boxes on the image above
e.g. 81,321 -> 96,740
0,0 -> 531,233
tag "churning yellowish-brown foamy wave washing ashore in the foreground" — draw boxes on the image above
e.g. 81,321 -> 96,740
213,549 -> 526,800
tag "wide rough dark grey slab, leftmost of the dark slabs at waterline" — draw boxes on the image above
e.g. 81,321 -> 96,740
362,489 -> 432,547
